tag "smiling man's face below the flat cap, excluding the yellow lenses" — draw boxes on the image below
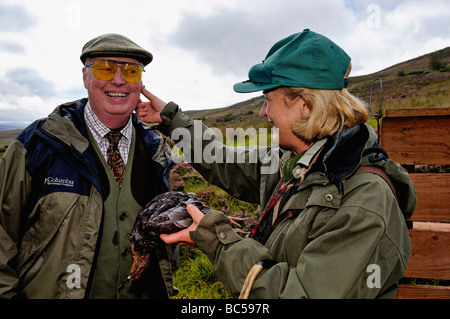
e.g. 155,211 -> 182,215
83,57 -> 142,129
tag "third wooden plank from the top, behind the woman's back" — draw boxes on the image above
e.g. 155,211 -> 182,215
404,223 -> 450,280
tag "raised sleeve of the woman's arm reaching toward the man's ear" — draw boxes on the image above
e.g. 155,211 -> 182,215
159,102 -> 269,203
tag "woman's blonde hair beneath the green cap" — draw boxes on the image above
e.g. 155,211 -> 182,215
281,65 -> 369,142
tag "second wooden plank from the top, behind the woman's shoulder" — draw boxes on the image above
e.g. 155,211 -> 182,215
409,173 -> 450,223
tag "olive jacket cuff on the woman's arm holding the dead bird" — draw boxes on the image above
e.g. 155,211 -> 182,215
189,210 -> 242,260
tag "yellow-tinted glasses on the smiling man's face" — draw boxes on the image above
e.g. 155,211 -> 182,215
85,59 -> 145,83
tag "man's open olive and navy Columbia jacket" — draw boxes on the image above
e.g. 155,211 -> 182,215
0,99 -> 177,298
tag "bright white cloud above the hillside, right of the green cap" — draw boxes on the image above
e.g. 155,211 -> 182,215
343,0 -> 450,75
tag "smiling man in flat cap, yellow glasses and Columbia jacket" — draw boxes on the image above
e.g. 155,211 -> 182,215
0,34 -> 176,298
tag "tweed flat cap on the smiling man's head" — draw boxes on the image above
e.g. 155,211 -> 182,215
80,33 -> 153,66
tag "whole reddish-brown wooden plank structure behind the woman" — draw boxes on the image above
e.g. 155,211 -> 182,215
380,108 -> 450,299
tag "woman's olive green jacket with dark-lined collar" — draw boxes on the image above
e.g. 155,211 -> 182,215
160,103 -> 416,298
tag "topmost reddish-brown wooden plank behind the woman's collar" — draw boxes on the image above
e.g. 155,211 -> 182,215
381,116 -> 450,165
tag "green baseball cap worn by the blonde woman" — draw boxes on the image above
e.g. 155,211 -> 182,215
233,29 -> 351,93
